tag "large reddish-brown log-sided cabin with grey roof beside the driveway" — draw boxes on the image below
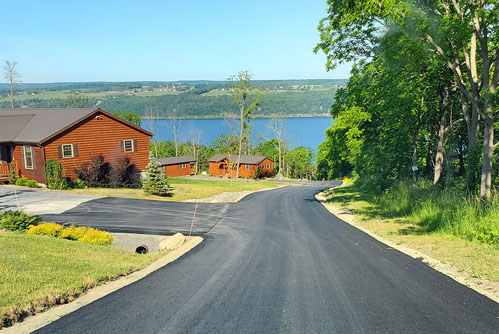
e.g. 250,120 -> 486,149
0,108 -> 152,183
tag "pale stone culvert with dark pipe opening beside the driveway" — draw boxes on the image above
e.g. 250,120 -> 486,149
111,233 -> 185,254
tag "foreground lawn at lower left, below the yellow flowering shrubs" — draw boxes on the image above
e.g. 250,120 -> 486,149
0,231 -> 160,328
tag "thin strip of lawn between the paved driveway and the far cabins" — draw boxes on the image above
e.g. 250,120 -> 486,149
68,177 -> 284,201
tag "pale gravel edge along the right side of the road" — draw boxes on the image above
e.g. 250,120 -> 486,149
315,192 -> 499,303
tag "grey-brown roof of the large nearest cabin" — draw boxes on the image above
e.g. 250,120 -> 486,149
0,108 -> 151,144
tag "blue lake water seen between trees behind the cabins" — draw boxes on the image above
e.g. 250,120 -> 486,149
142,117 -> 331,152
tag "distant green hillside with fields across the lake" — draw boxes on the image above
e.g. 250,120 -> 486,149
0,79 -> 347,118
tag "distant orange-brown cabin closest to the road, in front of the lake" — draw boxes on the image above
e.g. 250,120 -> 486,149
208,154 -> 274,178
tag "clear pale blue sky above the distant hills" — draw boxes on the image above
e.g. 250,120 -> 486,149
0,0 -> 351,83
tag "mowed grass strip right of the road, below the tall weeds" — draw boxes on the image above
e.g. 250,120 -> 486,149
328,186 -> 499,282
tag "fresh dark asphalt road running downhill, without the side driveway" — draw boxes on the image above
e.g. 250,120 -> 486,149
37,186 -> 499,333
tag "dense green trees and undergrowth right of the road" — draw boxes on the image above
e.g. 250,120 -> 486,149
316,0 -> 499,244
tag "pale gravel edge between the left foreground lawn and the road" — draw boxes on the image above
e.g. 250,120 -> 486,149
0,236 -> 203,334
